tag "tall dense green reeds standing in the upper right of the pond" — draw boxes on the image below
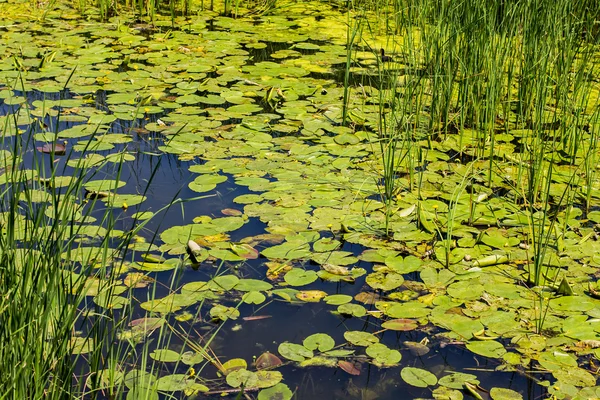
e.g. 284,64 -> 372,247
352,1 -> 600,234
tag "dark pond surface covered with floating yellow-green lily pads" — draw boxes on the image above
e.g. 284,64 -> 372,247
0,3 -> 600,400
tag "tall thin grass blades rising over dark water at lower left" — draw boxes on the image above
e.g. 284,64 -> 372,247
0,87 -> 185,399
